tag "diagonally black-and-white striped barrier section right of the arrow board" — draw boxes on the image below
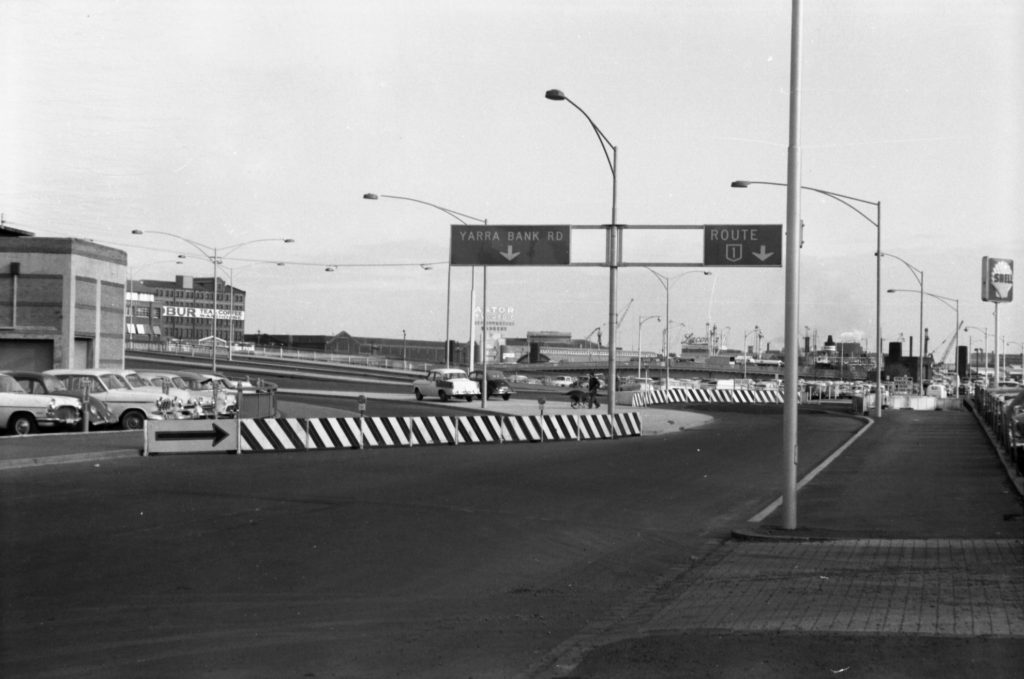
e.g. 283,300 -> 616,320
232,413 -> 642,453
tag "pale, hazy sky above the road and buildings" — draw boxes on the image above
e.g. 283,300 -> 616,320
0,0 -> 1024,353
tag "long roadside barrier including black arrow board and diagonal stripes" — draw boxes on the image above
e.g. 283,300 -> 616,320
143,413 -> 643,455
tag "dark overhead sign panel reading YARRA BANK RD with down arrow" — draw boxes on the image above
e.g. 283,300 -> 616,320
452,224 -> 571,266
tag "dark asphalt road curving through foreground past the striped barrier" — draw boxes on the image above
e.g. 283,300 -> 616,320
0,405 -> 859,679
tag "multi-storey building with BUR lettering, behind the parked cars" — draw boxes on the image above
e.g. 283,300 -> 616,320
125,275 -> 246,343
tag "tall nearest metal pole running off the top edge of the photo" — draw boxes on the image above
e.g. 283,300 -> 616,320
782,0 -> 802,531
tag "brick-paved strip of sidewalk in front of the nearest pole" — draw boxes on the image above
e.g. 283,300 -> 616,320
635,540 -> 1024,637
